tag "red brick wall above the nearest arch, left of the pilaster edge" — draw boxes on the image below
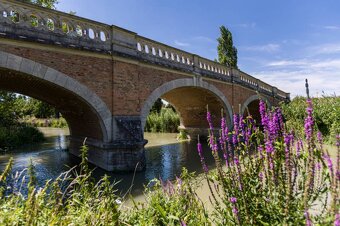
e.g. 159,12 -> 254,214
0,44 -> 113,111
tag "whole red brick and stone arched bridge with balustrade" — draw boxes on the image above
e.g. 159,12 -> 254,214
0,0 -> 289,171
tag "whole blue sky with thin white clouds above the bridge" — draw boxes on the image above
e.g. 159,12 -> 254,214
57,0 -> 340,96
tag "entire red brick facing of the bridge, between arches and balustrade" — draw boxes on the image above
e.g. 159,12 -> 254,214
0,41 -> 278,122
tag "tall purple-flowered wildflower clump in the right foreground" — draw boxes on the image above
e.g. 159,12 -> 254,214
198,100 -> 339,225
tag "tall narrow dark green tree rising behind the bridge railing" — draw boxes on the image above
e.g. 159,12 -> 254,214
217,26 -> 237,68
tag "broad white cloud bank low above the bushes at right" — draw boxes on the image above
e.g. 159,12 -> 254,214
253,58 -> 340,97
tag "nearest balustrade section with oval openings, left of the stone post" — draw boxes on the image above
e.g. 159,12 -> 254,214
0,0 -> 111,52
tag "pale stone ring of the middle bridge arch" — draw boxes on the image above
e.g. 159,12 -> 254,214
140,77 -> 233,130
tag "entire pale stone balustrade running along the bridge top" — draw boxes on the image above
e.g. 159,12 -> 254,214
0,0 -> 289,100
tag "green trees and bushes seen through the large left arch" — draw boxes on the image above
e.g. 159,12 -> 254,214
0,91 -> 67,149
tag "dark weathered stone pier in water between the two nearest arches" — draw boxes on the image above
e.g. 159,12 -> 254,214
69,116 -> 147,171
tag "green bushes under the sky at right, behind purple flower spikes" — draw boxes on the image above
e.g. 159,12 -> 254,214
281,96 -> 340,144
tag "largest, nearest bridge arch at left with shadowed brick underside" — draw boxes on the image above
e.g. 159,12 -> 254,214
0,51 -> 112,142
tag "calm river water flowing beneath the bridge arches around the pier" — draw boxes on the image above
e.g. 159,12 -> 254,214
0,128 -> 213,195
